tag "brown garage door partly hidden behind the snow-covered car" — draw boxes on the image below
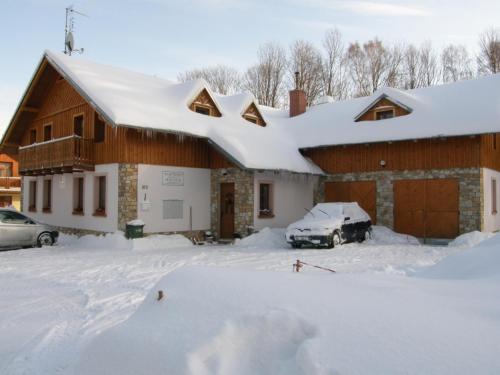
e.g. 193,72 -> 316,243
325,181 -> 377,224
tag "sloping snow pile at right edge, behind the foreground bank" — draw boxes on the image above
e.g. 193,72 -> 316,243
419,234 -> 500,279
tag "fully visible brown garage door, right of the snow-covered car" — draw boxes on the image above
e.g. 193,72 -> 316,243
394,179 -> 459,238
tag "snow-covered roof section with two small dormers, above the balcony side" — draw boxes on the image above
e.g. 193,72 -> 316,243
45,51 -> 322,174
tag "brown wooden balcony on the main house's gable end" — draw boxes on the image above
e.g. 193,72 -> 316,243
19,135 -> 94,176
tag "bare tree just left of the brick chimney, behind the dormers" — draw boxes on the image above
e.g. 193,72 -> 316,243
243,43 -> 287,107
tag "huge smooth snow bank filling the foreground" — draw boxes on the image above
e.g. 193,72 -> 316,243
75,267 -> 500,375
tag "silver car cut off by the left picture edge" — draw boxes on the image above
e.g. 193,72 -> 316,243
0,208 -> 59,249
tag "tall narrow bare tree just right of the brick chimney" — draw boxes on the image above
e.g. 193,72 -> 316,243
322,29 -> 349,100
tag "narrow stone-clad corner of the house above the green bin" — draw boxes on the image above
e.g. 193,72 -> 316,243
118,164 -> 138,231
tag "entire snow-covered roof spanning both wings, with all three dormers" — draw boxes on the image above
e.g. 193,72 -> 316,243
29,51 -> 500,173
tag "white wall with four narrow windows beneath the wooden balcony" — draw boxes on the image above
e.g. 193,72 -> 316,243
23,164 -> 118,232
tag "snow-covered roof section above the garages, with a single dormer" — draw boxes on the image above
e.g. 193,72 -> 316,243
282,78 -> 500,148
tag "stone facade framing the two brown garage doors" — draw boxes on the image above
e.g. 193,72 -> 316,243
314,168 -> 484,234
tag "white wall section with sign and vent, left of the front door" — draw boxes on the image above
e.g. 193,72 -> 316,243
137,164 -> 210,233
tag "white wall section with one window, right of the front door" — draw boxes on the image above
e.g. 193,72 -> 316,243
254,171 -> 317,230
